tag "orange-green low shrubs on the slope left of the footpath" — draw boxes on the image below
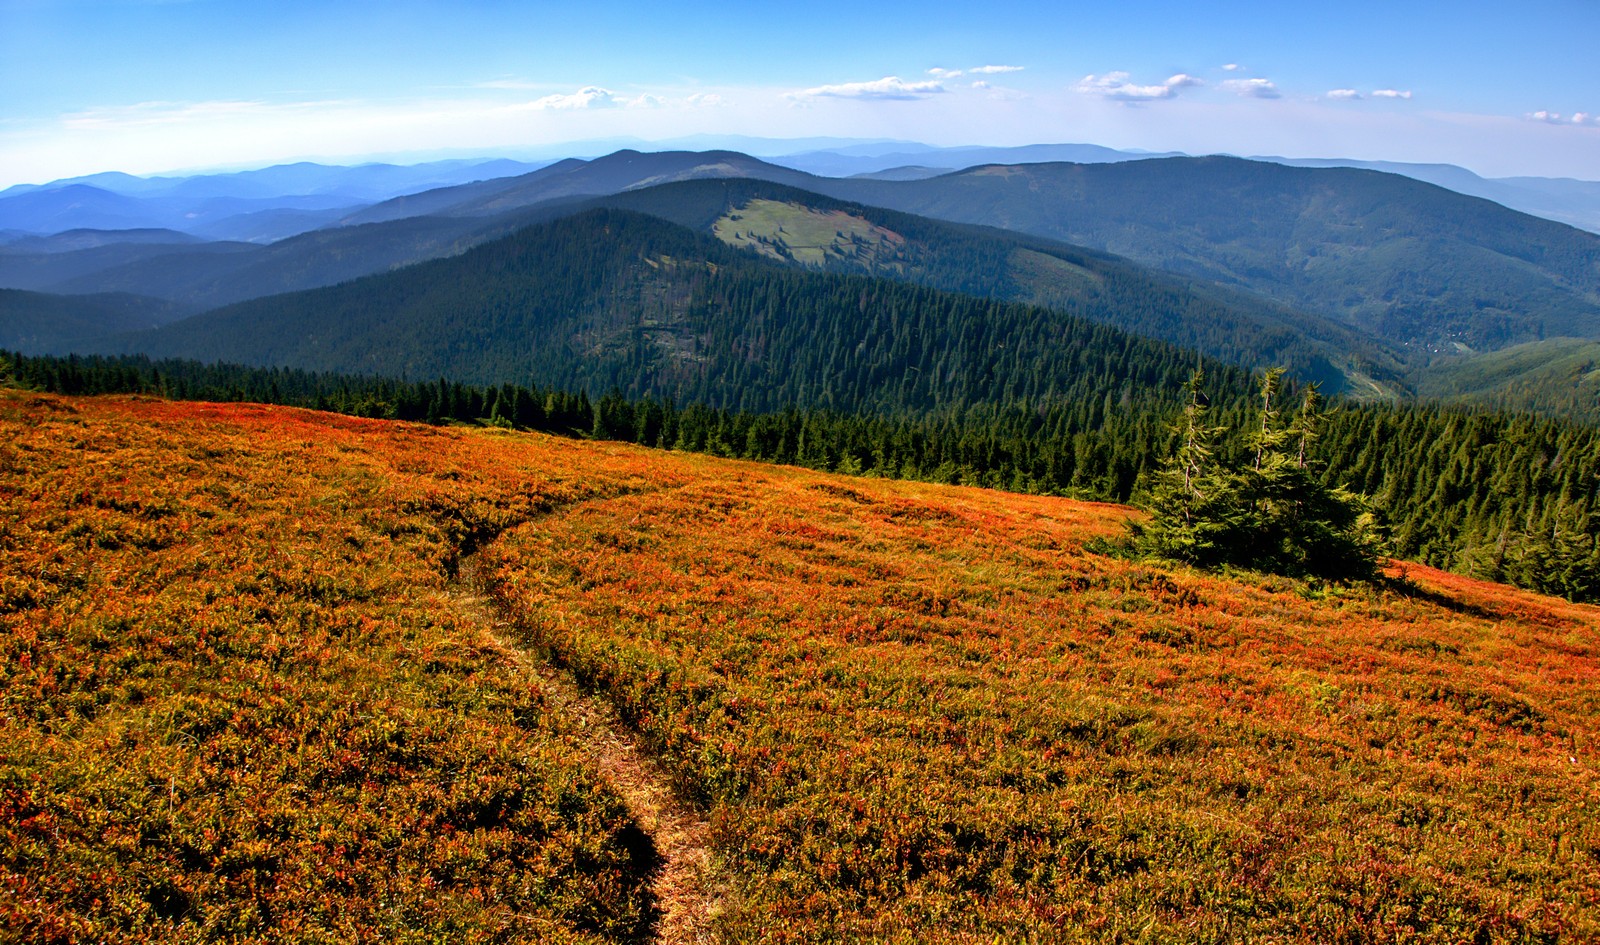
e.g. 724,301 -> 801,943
0,392 -> 668,943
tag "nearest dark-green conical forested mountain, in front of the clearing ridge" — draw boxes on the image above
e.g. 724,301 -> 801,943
96,209 -> 1260,411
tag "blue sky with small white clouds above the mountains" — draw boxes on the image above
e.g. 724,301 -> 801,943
0,0 -> 1600,187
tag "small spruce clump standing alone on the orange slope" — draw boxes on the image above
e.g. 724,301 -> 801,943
1133,369 -> 1378,580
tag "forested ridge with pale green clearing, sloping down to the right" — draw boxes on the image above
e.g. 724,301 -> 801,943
594,179 -> 1405,397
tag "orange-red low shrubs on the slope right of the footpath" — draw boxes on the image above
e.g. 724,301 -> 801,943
485,431 -> 1600,943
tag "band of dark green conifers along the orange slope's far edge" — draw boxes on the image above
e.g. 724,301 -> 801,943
0,353 -> 1600,601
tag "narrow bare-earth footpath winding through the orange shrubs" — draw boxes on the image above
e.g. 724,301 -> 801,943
450,556 -> 722,945
